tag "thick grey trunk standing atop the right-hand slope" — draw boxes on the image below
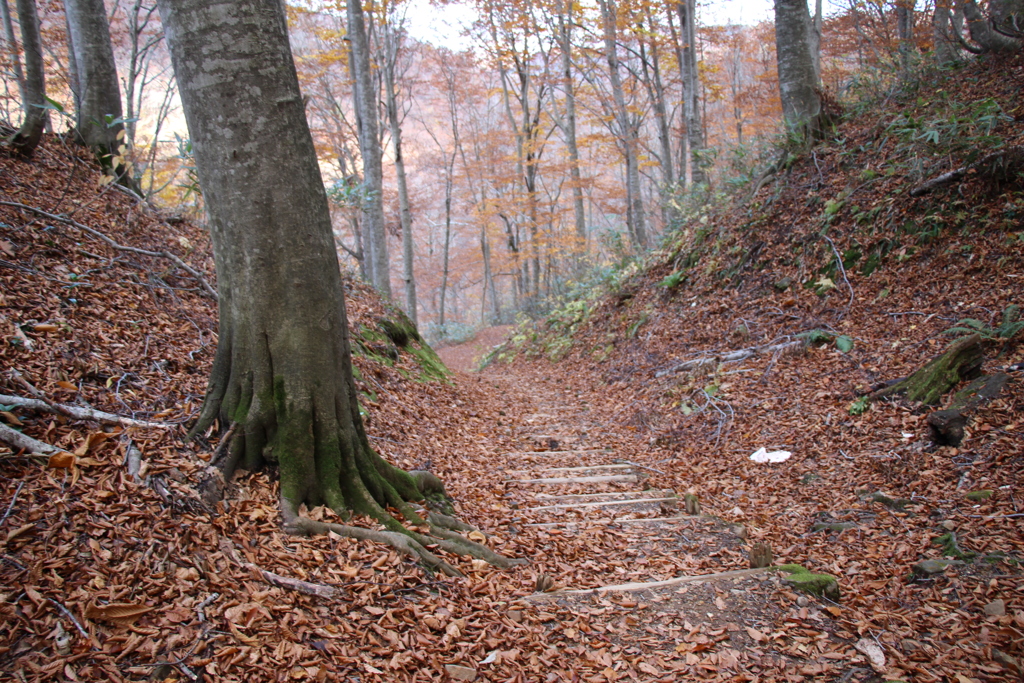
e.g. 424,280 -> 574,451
775,0 -> 821,135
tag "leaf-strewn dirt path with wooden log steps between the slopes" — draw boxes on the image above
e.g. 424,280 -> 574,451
471,367 -> 871,681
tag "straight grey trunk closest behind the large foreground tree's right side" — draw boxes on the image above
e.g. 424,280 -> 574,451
347,0 -> 391,298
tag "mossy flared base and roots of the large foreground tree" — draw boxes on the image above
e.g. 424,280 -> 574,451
193,325 -> 522,575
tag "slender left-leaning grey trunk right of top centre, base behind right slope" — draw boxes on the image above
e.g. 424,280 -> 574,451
598,0 -> 647,251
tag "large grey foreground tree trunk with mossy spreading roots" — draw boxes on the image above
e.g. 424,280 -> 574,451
159,0 -> 509,573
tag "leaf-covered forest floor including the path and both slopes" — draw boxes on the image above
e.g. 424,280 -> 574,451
0,53 -> 1024,683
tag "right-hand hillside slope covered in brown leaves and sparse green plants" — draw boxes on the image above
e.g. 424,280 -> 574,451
484,55 -> 1024,680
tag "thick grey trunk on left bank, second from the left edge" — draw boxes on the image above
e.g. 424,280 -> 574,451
65,0 -> 134,188
